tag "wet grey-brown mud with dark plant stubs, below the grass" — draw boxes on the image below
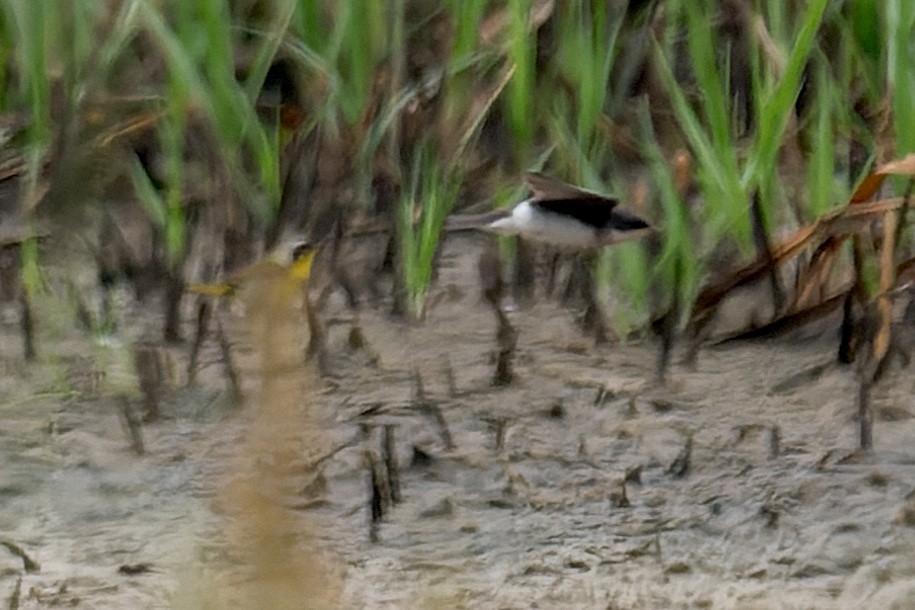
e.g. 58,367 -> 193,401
0,230 -> 915,609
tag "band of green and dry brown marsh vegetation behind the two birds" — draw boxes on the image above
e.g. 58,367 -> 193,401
0,0 -> 915,326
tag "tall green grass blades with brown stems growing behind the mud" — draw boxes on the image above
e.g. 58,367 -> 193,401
0,0 -> 915,332
